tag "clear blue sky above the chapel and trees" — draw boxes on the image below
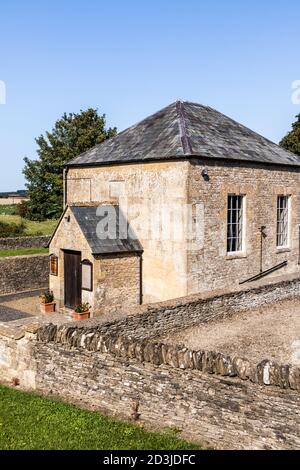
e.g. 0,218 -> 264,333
0,0 -> 300,191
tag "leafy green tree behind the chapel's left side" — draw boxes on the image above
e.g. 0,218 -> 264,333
23,108 -> 117,220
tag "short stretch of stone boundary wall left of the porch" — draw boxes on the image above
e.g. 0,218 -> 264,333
0,255 -> 49,295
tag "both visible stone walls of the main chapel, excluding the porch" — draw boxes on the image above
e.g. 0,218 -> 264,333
67,159 -> 300,303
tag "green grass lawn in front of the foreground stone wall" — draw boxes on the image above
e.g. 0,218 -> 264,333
0,386 -> 199,450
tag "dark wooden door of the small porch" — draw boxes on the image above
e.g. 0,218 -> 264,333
64,251 -> 81,308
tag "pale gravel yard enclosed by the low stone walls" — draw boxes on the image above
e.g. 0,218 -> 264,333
164,300 -> 300,366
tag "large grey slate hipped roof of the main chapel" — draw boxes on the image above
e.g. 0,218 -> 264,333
67,101 -> 300,167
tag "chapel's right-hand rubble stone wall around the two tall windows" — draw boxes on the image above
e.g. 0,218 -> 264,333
188,160 -> 300,294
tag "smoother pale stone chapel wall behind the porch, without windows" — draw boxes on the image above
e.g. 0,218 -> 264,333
67,161 -> 189,303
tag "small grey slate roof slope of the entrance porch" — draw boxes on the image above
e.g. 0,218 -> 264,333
70,205 -> 143,255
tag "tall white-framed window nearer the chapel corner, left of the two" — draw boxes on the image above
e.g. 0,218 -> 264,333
227,194 -> 245,253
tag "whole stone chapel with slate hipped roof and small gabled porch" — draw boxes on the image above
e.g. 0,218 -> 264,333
50,101 -> 300,316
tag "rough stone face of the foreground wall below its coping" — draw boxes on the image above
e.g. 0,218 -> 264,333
34,343 -> 300,449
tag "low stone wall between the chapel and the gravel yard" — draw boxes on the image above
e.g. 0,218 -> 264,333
77,278 -> 300,341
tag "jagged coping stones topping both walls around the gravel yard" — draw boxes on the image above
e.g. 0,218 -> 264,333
37,272 -> 300,391
